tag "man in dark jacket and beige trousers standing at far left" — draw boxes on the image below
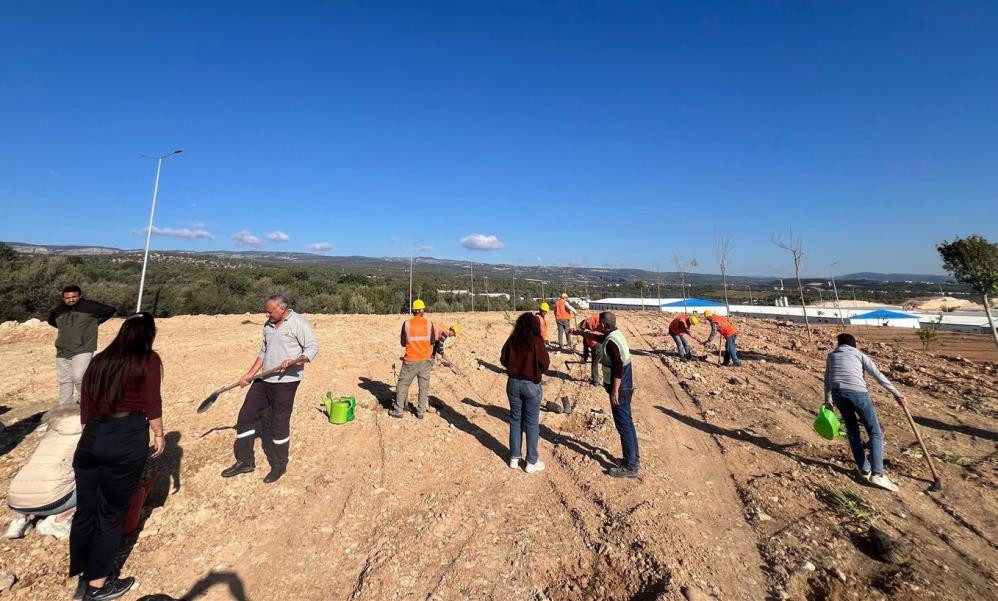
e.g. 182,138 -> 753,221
49,285 -> 114,404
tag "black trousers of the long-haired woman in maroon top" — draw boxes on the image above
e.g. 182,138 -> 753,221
69,413 -> 149,580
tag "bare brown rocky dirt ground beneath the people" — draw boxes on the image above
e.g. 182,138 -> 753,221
0,313 -> 998,601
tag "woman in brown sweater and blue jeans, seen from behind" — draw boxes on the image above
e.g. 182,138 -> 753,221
499,313 -> 551,474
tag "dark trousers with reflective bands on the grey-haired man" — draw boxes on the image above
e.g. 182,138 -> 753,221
233,380 -> 301,467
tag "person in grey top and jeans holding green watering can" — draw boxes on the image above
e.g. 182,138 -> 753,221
825,334 -> 905,492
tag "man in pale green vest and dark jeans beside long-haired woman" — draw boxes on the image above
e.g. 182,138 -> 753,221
573,311 -> 641,478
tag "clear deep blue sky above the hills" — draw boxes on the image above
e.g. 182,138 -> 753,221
0,0 -> 998,275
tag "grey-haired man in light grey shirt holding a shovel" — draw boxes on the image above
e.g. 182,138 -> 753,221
222,294 -> 319,484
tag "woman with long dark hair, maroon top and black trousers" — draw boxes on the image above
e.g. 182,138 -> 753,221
69,313 -> 166,601
